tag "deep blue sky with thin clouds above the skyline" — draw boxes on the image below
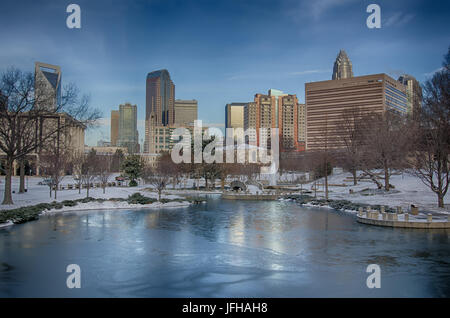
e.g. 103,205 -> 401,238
0,0 -> 450,145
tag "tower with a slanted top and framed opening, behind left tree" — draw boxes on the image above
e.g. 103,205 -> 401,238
34,62 -> 61,111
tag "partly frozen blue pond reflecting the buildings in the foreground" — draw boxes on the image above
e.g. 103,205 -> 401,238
0,197 -> 450,297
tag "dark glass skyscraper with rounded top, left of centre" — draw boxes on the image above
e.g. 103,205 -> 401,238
144,70 -> 175,152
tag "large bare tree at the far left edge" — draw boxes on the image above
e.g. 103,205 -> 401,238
0,68 -> 100,204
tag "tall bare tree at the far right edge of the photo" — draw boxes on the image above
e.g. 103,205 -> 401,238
410,48 -> 450,208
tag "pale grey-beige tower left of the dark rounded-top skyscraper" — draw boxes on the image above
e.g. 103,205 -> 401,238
117,103 -> 139,153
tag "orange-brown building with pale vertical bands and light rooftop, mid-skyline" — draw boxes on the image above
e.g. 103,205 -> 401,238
244,89 -> 304,151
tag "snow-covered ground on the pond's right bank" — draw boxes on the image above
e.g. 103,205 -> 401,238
303,173 -> 450,214
